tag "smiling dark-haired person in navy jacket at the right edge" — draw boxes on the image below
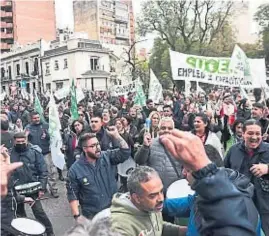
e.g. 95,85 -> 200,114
224,120 -> 269,235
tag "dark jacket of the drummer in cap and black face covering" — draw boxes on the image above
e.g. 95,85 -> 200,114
10,145 -> 48,190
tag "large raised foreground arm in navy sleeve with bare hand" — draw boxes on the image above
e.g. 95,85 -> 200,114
160,130 -> 256,236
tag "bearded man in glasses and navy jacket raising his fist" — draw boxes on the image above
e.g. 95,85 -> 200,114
66,127 -> 131,220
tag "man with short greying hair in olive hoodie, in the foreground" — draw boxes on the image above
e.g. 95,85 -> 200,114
110,166 -> 185,236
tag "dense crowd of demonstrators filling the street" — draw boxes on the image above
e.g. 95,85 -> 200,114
1,88 -> 269,236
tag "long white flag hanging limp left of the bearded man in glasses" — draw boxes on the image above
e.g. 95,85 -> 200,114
49,95 -> 65,170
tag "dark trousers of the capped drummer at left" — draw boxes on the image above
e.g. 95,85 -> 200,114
17,195 -> 53,234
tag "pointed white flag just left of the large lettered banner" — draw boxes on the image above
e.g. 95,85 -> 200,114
148,69 -> 163,104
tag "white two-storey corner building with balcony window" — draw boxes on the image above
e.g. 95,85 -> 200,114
41,37 -> 111,91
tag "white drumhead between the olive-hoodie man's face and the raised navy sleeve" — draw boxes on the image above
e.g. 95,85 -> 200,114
166,179 -> 194,198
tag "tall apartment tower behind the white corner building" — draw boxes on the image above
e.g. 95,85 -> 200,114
73,0 -> 135,46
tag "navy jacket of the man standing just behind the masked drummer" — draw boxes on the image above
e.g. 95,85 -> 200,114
25,122 -> 50,155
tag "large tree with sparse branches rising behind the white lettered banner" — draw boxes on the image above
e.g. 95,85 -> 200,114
138,0 -> 235,88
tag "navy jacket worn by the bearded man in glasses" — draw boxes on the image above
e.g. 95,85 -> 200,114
66,149 -> 131,218
